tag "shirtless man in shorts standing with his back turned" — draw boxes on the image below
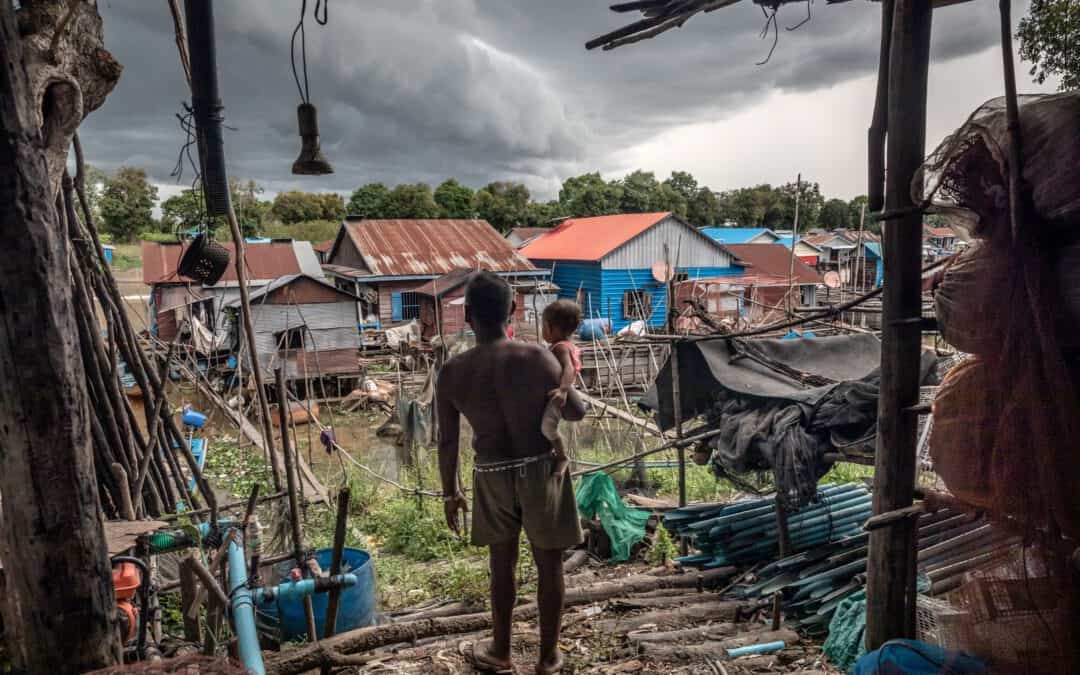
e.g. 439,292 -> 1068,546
435,272 -> 585,675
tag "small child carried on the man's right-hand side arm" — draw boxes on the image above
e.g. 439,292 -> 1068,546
540,300 -> 581,475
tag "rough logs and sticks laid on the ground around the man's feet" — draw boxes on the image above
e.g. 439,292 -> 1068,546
267,552 -> 838,675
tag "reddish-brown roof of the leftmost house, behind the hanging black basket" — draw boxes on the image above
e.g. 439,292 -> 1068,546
143,241 -> 319,285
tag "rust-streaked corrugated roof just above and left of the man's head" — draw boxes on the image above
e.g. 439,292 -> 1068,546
329,219 -> 537,278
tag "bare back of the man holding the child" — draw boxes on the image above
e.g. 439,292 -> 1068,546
438,340 -> 558,462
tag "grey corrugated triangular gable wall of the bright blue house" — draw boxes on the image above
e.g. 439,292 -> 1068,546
600,217 -> 732,270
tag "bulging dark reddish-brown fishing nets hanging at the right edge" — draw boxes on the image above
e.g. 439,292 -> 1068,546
913,92 -> 1080,670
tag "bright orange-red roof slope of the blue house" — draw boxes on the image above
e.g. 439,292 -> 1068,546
522,213 -> 671,260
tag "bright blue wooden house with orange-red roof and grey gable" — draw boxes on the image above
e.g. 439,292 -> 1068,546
519,213 -> 743,330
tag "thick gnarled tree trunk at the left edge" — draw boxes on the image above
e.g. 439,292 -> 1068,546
0,2 -> 120,673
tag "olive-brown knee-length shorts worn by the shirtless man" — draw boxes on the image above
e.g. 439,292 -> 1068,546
472,458 -> 583,550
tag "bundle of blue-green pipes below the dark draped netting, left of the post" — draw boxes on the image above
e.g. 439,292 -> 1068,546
664,483 -> 873,568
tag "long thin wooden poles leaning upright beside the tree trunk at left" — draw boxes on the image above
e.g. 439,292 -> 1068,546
56,137 -> 217,519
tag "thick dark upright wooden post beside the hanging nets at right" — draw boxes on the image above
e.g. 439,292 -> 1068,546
866,0 -> 933,650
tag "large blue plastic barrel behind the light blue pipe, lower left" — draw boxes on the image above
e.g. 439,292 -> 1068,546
263,549 -> 377,642
